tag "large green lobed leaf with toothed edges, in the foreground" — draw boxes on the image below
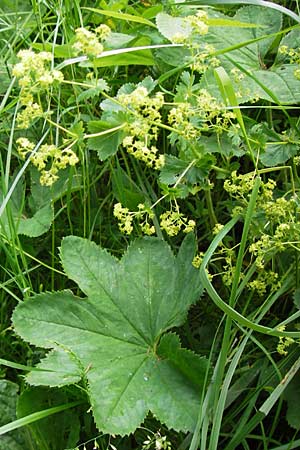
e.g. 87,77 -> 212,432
13,235 -> 206,435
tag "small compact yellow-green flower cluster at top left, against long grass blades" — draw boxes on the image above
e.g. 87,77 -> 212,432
73,24 -> 111,58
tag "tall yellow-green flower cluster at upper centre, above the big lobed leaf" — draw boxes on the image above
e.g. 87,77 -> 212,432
117,86 -> 164,170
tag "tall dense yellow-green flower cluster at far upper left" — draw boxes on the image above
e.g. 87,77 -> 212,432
12,50 -> 63,128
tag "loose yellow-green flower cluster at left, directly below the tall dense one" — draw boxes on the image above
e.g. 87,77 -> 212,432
17,137 -> 78,186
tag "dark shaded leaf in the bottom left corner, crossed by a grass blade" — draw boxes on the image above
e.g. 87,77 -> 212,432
0,380 -> 25,450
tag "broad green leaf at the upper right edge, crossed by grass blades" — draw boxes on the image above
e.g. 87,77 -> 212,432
201,6 -> 300,104
